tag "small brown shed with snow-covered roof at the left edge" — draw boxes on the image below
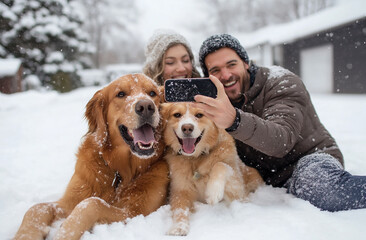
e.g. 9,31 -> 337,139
0,59 -> 23,94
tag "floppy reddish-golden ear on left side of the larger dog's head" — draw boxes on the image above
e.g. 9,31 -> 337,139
85,90 -> 108,143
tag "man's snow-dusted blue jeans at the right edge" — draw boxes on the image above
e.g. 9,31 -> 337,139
285,153 -> 366,212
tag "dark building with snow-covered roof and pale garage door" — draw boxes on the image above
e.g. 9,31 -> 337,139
237,1 -> 366,93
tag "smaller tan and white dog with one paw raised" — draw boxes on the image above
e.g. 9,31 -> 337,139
162,103 -> 263,235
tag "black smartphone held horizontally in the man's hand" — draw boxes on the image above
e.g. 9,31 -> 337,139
164,78 -> 217,102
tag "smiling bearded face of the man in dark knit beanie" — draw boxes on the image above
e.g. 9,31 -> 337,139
205,47 -> 250,102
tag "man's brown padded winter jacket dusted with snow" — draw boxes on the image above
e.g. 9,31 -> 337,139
230,66 -> 343,187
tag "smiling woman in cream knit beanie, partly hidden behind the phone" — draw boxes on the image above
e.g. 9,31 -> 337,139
143,30 -> 200,86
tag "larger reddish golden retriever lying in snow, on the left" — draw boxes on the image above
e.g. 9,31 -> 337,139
14,74 -> 169,240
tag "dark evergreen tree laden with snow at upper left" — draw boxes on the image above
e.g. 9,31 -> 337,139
0,0 -> 90,92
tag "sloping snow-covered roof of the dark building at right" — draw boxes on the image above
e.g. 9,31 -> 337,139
237,0 -> 366,48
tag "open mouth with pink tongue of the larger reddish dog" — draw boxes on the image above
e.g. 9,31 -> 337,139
119,124 -> 157,156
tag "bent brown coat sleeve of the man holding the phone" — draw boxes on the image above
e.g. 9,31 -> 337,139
231,74 -> 309,158
